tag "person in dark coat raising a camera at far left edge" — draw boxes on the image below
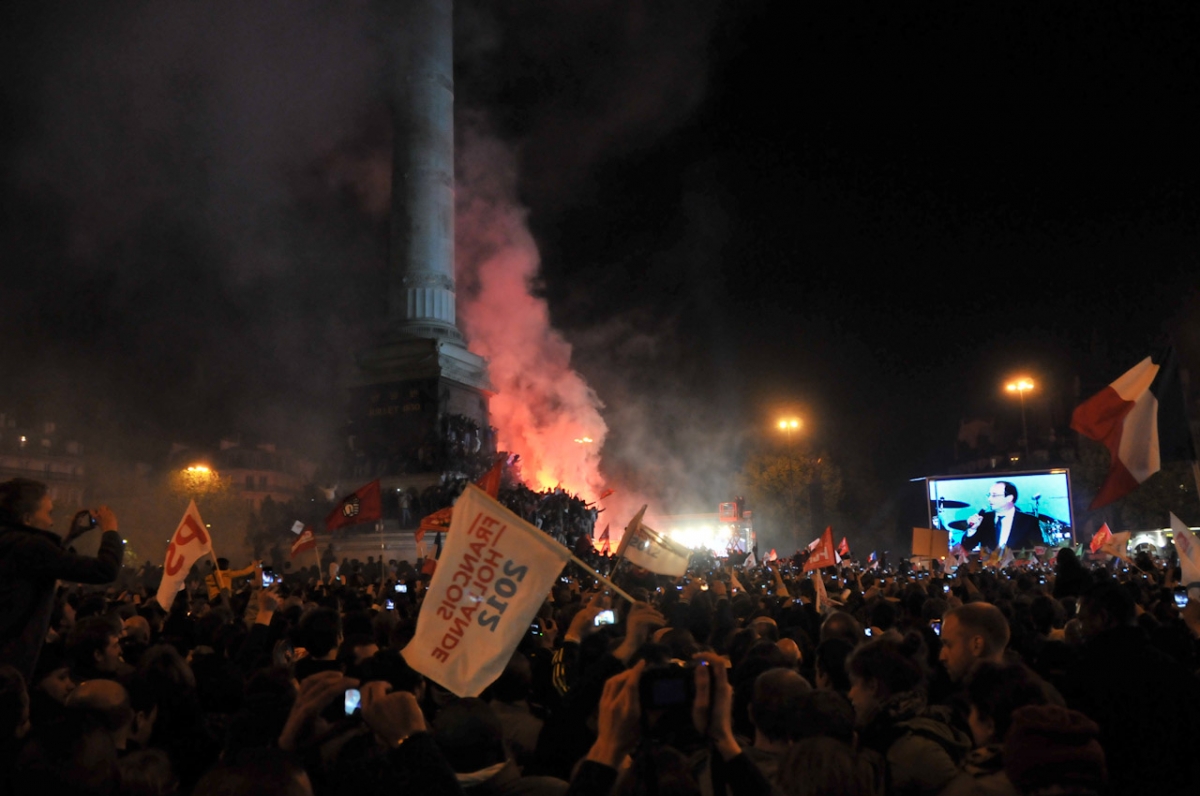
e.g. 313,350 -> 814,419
0,478 -> 125,680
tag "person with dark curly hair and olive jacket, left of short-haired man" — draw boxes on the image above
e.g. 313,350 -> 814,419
846,633 -> 971,795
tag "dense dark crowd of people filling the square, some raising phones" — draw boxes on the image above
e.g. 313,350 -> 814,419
0,480 -> 1200,796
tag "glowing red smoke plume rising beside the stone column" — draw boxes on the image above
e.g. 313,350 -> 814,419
455,133 -> 608,501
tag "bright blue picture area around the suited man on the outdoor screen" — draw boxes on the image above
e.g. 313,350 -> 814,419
925,469 -> 1074,545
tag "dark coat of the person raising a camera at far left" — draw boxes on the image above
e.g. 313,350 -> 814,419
0,525 -> 125,681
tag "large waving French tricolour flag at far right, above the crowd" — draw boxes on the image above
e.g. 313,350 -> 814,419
1070,348 -> 1195,509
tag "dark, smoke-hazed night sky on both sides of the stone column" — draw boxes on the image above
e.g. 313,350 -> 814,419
0,0 -> 1200,537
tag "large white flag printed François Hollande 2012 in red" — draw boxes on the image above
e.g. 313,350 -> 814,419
402,485 -> 571,696
